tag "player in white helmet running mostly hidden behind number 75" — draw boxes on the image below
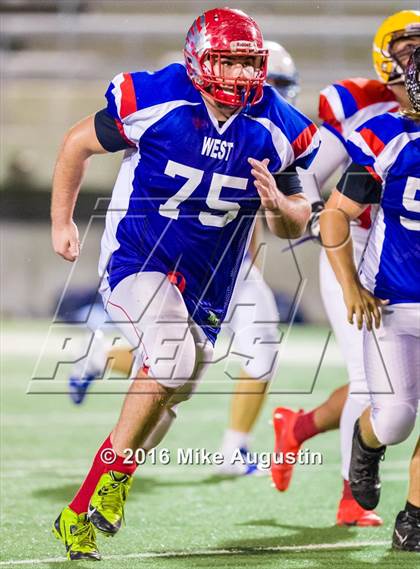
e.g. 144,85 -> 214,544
64,40 -> 300,476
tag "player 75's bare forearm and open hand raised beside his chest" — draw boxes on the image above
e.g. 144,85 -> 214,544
248,158 -> 311,239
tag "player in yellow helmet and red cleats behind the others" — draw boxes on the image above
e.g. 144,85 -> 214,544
272,10 -> 420,540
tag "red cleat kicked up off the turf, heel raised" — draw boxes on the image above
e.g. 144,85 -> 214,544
271,407 -> 304,492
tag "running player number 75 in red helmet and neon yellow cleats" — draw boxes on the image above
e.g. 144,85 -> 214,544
52,8 -> 318,559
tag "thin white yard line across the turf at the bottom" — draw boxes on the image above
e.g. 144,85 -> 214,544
0,541 -> 389,567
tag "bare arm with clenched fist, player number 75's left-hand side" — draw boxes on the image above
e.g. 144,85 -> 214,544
51,115 -> 107,262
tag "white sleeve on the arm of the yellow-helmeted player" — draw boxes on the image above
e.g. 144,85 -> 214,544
297,126 -> 348,203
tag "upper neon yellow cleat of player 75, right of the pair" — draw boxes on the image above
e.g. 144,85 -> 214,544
88,471 -> 133,536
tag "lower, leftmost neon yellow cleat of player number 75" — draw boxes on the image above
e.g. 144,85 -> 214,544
52,507 -> 101,561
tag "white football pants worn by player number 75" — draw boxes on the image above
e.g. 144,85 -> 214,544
103,272 -> 213,394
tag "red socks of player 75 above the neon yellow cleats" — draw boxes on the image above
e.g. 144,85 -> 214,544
69,436 -> 137,514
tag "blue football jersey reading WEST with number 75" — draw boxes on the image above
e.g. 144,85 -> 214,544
99,63 -> 319,342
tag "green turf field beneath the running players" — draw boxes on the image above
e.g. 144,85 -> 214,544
0,322 -> 419,569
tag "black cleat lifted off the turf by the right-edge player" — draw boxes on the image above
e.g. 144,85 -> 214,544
349,420 -> 386,510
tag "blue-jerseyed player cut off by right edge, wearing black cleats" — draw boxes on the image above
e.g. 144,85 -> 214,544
321,48 -> 420,552
